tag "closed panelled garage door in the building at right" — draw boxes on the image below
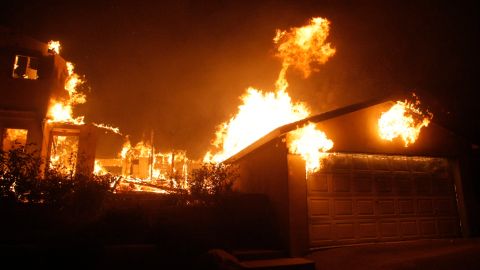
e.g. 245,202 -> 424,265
307,154 -> 460,247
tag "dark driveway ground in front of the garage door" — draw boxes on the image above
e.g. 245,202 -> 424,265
308,239 -> 480,270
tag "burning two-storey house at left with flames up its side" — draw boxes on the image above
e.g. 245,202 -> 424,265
0,28 -> 96,174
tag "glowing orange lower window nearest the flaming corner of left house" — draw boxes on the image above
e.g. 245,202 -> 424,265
49,135 -> 79,174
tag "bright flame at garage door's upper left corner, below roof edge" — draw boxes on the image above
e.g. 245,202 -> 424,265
287,123 -> 333,173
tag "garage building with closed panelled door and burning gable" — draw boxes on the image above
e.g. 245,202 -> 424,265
226,96 -> 471,255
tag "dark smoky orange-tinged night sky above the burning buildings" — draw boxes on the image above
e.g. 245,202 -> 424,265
0,0 -> 480,158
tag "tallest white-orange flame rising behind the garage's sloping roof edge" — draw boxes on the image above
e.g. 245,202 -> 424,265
204,17 -> 335,163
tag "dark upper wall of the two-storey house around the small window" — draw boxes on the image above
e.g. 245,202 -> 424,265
0,28 -> 67,159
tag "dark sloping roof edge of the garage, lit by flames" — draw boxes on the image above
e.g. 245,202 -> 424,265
224,91 -> 457,163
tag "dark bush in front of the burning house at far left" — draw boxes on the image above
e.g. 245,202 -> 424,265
0,146 -> 118,211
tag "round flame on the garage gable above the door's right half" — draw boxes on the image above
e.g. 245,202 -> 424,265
378,99 -> 433,147
